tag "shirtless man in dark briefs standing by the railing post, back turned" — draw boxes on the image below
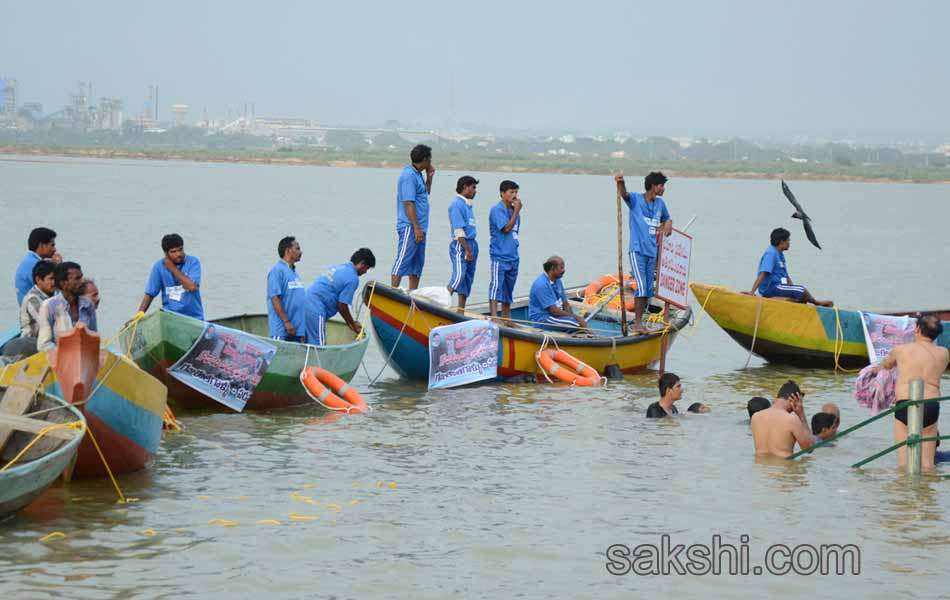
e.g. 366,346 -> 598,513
873,315 -> 950,469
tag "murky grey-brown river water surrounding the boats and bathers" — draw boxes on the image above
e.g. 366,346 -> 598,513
0,157 -> 950,598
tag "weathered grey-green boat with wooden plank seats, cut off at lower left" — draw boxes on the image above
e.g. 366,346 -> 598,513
0,365 -> 85,520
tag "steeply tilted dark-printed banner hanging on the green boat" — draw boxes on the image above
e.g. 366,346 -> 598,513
168,323 -> 277,412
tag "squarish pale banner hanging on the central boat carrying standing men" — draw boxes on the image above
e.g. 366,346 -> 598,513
429,320 -> 498,390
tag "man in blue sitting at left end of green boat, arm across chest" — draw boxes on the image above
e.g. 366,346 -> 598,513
139,233 -> 205,321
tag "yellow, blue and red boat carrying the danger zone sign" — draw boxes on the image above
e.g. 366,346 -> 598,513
363,281 -> 691,380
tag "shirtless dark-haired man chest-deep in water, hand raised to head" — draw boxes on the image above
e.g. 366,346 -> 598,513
751,380 -> 815,458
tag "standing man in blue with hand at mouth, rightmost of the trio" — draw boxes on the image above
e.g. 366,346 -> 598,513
488,179 -> 521,319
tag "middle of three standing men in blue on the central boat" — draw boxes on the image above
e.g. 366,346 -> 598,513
446,175 -> 478,312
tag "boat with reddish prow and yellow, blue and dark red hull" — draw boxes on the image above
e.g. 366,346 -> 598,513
0,325 -> 168,477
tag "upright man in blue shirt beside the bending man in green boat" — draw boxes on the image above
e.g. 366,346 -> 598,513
267,236 -> 307,342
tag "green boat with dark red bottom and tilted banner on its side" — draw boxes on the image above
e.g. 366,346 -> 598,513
119,310 -> 369,412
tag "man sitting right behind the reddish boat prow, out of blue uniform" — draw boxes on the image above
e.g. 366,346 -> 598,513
36,262 -> 98,352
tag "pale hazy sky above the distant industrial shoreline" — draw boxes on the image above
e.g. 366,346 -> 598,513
0,0 -> 950,137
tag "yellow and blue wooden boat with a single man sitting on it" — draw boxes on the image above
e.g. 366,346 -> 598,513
689,282 -> 950,369
